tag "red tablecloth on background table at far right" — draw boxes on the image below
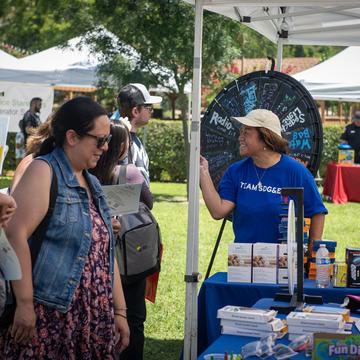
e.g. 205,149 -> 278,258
323,162 -> 360,204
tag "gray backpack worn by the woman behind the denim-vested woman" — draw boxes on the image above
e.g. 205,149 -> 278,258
115,165 -> 161,284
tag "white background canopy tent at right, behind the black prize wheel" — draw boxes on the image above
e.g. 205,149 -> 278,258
293,46 -> 360,102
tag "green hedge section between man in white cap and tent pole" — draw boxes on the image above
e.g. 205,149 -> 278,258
138,120 -> 186,182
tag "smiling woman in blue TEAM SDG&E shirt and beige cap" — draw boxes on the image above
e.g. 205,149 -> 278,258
200,109 -> 327,249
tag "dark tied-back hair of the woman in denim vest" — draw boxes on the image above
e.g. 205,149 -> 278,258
39,97 -> 107,155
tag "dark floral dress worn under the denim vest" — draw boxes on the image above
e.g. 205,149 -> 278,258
0,198 -> 115,360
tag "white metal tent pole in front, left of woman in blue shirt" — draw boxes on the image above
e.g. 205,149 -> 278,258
184,0 -> 203,360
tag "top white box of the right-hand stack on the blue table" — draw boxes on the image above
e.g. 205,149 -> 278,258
286,311 -> 345,330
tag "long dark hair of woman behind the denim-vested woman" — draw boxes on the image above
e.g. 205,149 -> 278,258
89,120 -> 130,185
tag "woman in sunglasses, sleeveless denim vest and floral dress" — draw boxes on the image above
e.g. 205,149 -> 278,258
0,97 -> 129,360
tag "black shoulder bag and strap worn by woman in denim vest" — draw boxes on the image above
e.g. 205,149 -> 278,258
0,165 -> 58,331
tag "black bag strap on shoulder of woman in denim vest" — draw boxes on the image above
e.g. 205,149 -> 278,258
30,164 -> 58,268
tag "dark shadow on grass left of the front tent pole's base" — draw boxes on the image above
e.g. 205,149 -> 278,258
144,337 -> 184,360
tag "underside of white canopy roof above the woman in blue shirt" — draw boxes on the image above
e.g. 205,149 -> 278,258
184,0 -> 360,46
